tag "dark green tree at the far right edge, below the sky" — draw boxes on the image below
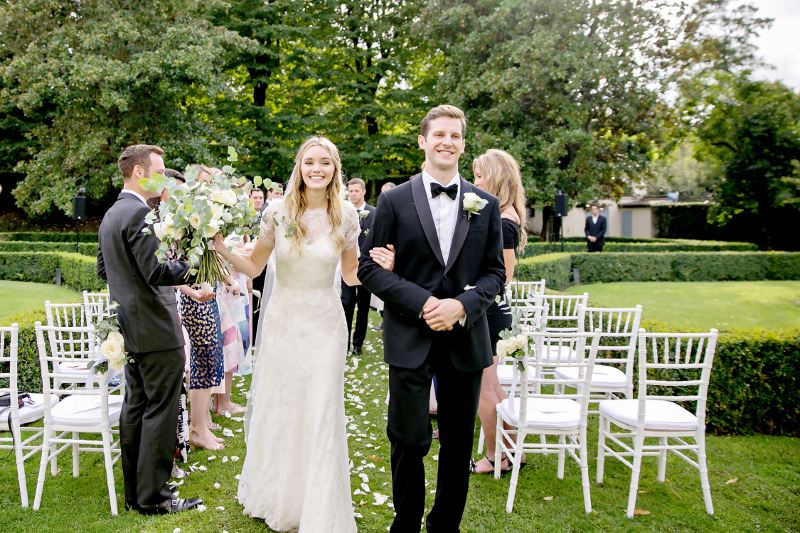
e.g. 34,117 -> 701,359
696,73 -> 800,250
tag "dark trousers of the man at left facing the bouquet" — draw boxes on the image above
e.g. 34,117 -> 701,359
119,347 -> 185,508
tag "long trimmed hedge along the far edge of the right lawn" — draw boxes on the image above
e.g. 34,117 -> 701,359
517,252 -> 800,290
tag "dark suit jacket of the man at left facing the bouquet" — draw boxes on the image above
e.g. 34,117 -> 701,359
97,193 -> 191,353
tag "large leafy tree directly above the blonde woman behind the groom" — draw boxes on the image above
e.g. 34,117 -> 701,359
421,0 -> 670,212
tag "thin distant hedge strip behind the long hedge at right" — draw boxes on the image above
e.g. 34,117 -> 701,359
522,239 -> 758,257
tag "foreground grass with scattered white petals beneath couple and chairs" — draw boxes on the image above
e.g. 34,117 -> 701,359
0,314 -> 800,533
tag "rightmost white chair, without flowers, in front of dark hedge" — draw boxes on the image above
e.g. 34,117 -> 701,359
597,329 -> 717,518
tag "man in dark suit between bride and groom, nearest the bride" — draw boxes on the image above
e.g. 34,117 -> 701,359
342,178 -> 375,355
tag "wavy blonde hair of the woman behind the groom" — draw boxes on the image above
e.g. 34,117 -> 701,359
472,148 -> 528,250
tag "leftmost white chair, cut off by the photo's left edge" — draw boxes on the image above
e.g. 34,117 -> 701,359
0,324 -> 58,507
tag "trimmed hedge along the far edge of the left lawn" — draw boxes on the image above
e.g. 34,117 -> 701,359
0,252 -> 106,291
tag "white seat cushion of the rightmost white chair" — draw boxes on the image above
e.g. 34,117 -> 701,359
600,400 -> 697,431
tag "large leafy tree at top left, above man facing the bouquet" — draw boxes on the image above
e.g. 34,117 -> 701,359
0,0 -> 253,214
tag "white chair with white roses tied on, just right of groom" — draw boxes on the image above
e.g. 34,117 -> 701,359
494,332 -> 600,513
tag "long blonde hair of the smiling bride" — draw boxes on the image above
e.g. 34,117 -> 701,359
283,136 -> 345,252
